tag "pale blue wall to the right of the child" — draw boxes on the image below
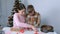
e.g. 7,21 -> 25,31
28,0 -> 60,34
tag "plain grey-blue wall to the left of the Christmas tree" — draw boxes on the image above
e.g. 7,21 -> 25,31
0,0 -> 14,26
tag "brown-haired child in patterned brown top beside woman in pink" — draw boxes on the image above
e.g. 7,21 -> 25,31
27,5 -> 40,27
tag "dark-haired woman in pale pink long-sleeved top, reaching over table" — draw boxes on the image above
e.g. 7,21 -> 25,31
13,3 -> 36,31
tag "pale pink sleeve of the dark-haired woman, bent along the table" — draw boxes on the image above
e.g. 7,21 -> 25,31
13,14 -> 31,27
